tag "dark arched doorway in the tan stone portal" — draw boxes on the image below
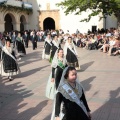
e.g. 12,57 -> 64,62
43,17 -> 55,30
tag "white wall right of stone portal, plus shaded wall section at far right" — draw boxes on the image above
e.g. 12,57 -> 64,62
37,0 -> 117,33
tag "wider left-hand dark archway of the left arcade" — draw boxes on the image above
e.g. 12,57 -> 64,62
4,14 -> 14,32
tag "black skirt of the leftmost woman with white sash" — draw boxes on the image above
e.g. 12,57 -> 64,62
2,52 -> 18,73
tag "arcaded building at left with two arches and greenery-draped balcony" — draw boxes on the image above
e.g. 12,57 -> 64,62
0,0 -> 32,32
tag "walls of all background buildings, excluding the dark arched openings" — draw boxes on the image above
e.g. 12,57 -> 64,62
0,0 -> 117,33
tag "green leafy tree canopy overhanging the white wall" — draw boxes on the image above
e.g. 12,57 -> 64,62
56,0 -> 120,22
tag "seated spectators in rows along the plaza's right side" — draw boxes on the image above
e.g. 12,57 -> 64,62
72,29 -> 120,56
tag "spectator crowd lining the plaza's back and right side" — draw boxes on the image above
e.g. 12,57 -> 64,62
0,29 -> 120,56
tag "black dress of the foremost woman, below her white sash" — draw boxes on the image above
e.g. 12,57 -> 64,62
55,93 -> 90,120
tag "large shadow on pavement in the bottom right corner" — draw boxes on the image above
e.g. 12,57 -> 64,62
92,87 -> 120,120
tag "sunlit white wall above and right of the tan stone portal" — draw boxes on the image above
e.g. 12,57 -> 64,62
38,0 -> 103,33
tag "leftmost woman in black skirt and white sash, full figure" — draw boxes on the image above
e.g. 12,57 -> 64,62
0,37 -> 20,81
